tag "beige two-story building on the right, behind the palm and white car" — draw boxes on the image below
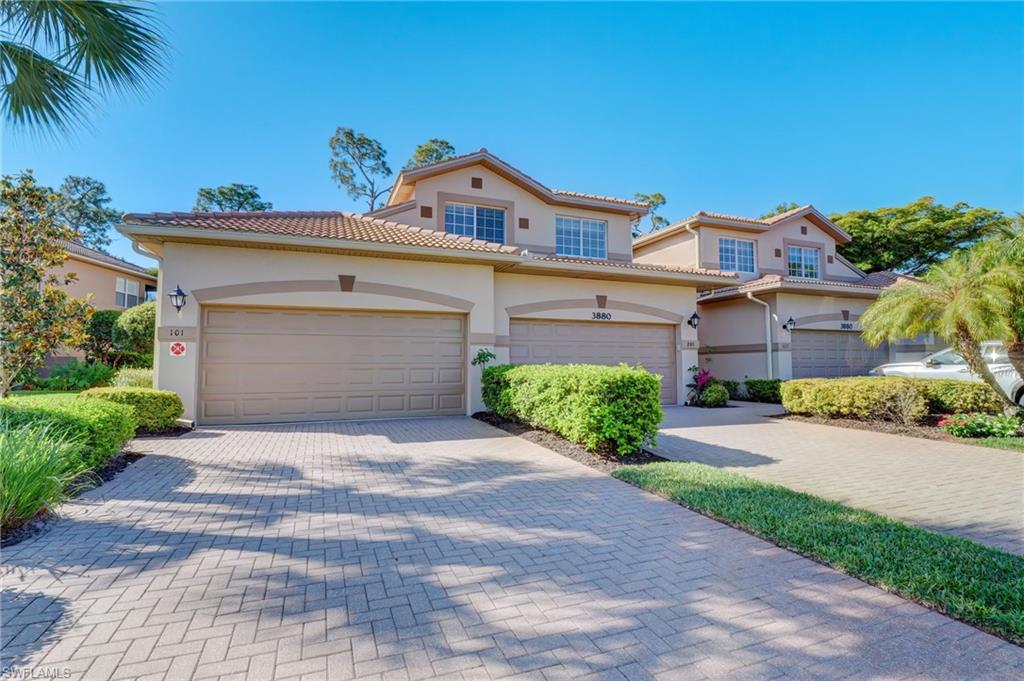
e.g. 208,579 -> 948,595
633,206 -> 941,380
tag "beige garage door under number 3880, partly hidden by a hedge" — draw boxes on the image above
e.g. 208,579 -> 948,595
509,320 -> 676,403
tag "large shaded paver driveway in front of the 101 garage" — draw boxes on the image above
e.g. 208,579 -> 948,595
3,418 -> 1024,681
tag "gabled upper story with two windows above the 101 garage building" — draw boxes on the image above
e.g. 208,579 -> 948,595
370,148 -> 647,261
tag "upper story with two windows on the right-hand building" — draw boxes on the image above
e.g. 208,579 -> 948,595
633,206 -> 864,282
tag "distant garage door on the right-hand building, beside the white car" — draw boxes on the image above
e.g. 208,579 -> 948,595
793,329 -> 889,378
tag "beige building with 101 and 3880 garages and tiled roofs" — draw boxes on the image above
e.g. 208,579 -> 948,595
119,150 -> 735,424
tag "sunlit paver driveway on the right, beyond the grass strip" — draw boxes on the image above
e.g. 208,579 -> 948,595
655,402 -> 1024,554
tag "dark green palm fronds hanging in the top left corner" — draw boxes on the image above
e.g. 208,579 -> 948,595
0,0 -> 164,132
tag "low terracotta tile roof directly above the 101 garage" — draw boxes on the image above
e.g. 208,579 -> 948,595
124,211 -> 519,253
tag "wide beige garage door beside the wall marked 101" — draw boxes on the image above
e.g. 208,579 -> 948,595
198,307 -> 466,424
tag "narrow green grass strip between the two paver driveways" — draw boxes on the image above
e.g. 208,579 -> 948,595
612,462 -> 1024,644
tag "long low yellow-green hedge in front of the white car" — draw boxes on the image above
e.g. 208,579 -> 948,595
781,376 -> 1002,423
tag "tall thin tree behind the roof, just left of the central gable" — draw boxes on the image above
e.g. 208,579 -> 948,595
328,127 -> 391,211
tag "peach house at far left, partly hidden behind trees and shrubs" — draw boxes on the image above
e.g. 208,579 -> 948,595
44,242 -> 157,366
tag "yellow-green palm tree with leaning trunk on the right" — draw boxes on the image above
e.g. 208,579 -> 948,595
860,248 -> 1017,410
